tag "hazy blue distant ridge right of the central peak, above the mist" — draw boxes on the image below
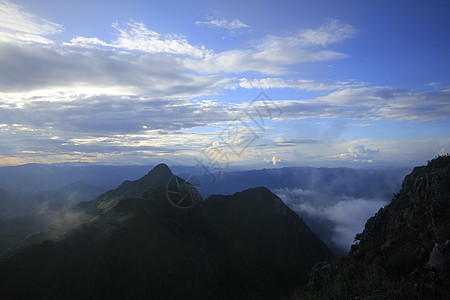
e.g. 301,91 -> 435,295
199,167 -> 410,201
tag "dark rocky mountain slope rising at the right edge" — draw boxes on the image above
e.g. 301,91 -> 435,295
293,155 -> 450,299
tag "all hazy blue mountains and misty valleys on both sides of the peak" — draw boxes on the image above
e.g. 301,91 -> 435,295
0,164 -> 409,256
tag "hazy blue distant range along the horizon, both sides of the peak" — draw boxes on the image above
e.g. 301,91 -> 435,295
0,164 -> 410,198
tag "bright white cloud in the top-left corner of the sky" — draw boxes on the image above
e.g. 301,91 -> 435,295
0,0 -> 64,44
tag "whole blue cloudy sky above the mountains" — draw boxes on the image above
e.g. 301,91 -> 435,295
0,0 -> 450,172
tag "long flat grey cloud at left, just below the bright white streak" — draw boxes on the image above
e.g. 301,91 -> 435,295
0,96 -> 234,136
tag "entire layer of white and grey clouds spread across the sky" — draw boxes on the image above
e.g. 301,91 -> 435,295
0,1 -> 450,165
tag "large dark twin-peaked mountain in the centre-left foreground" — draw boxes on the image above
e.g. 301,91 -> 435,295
0,165 -> 332,299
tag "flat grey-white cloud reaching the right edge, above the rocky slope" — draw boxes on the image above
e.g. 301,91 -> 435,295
258,87 -> 450,122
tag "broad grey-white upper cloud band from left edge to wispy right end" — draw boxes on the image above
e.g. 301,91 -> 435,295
0,12 -> 356,99
